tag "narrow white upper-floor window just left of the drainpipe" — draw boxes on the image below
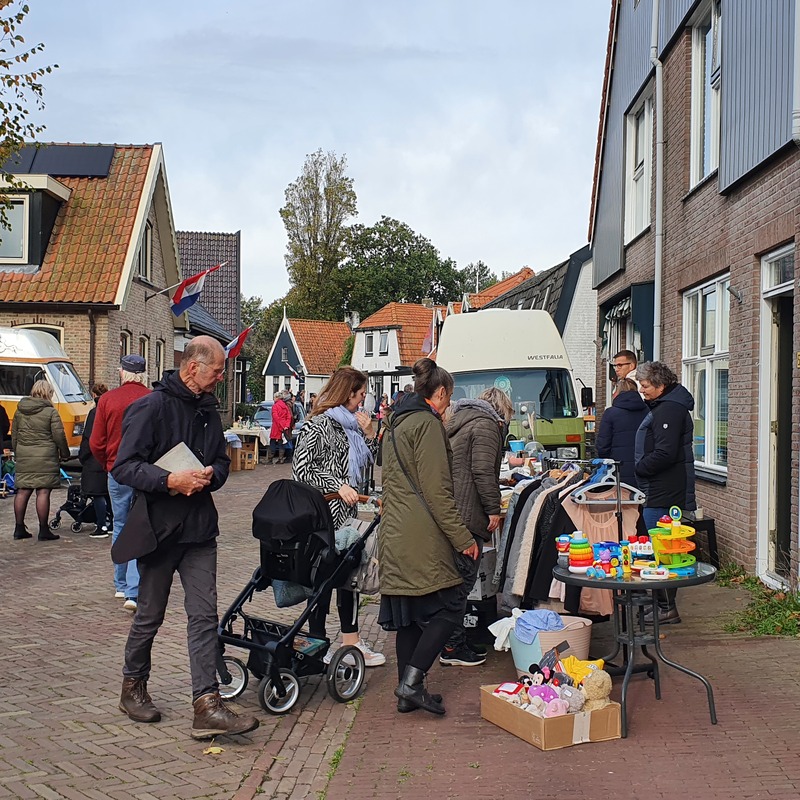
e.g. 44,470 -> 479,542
625,95 -> 653,242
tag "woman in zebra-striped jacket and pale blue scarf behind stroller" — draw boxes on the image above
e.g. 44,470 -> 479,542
292,367 -> 386,667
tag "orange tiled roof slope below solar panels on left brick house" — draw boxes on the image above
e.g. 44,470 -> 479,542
0,145 -> 153,304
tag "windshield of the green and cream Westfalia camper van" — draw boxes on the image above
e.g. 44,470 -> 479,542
453,369 -> 578,420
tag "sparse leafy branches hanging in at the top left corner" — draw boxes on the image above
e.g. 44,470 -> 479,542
0,0 -> 58,230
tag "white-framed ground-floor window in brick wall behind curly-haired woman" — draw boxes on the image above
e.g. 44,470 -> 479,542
683,275 -> 731,471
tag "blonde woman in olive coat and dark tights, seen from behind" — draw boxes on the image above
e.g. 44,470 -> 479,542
11,380 -> 69,541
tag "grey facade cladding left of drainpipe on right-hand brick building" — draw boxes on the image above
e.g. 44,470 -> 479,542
592,0 -> 653,288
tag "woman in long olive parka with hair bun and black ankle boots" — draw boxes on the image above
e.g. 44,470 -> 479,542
378,358 -> 480,714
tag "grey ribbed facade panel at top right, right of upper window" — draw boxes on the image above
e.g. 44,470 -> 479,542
719,0 -> 795,190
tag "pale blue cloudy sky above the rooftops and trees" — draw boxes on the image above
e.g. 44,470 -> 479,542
25,0 -> 611,304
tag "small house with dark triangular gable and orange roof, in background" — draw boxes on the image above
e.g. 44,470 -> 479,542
261,310 -> 352,401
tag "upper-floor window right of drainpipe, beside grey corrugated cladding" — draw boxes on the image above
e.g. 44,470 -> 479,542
691,0 -> 722,186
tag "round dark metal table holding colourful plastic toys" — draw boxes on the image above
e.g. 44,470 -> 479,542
553,563 -> 717,739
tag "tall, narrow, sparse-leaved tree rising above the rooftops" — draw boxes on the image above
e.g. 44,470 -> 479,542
280,149 -> 356,319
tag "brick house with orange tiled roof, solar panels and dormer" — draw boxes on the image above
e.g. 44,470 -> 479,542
0,144 -> 180,388
